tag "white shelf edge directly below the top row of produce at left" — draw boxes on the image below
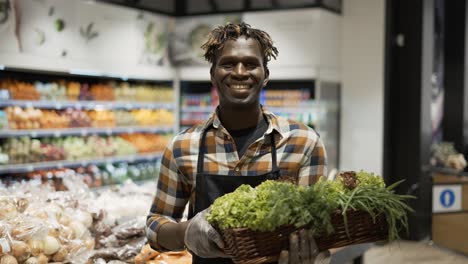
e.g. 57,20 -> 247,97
0,100 -> 175,110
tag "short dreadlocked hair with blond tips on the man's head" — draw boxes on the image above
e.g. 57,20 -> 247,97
201,22 -> 278,67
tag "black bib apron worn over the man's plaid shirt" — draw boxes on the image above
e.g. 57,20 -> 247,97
188,129 -> 280,264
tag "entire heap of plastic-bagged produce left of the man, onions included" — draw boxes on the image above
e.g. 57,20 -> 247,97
0,176 -> 186,264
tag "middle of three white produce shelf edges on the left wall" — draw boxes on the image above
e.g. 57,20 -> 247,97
0,126 -> 174,138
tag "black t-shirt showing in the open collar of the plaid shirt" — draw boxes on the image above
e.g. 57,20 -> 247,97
229,118 -> 268,159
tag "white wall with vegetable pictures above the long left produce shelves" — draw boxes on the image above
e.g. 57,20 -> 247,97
0,0 -> 174,80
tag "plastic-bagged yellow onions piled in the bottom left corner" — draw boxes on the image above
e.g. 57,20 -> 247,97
0,183 -> 95,264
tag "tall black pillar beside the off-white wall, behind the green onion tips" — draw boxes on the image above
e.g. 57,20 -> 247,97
384,0 -> 434,240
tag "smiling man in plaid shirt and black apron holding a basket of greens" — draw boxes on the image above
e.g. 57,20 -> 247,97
146,23 -> 326,264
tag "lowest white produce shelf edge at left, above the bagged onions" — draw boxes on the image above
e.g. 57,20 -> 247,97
0,152 -> 162,174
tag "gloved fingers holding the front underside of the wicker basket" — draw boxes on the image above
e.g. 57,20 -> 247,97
278,229 -> 330,264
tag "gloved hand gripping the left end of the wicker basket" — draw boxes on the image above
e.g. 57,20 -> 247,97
184,208 -> 229,258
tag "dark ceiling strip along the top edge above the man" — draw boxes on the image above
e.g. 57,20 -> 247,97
97,0 -> 342,16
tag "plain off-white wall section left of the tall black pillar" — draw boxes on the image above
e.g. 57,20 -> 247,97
340,0 -> 385,174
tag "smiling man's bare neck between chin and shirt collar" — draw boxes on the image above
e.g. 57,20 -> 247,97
218,105 -> 263,131
